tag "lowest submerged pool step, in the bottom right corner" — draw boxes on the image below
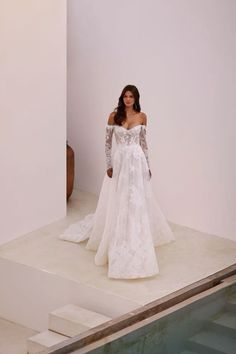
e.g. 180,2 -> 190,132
186,330 -> 236,354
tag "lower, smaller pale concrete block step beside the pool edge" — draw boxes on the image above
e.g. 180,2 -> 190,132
27,331 -> 68,354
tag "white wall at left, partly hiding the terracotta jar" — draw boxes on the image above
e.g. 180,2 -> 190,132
0,0 -> 66,243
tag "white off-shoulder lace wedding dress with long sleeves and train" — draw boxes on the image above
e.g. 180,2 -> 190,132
60,124 -> 174,279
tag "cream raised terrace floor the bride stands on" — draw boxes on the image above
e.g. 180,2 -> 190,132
0,191 -> 236,305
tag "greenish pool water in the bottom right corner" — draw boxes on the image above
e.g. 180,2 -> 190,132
89,284 -> 236,354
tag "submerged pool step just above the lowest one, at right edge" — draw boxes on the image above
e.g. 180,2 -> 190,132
209,312 -> 236,338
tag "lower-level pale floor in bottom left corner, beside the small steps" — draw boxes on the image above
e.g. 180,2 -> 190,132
0,318 -> 37,354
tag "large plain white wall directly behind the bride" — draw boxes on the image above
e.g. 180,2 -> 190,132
68,0 -> 236,240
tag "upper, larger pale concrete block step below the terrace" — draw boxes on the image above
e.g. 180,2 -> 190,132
49,304 -> 111,337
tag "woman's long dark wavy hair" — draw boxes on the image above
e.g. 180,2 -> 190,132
114,85 -> 141,125
